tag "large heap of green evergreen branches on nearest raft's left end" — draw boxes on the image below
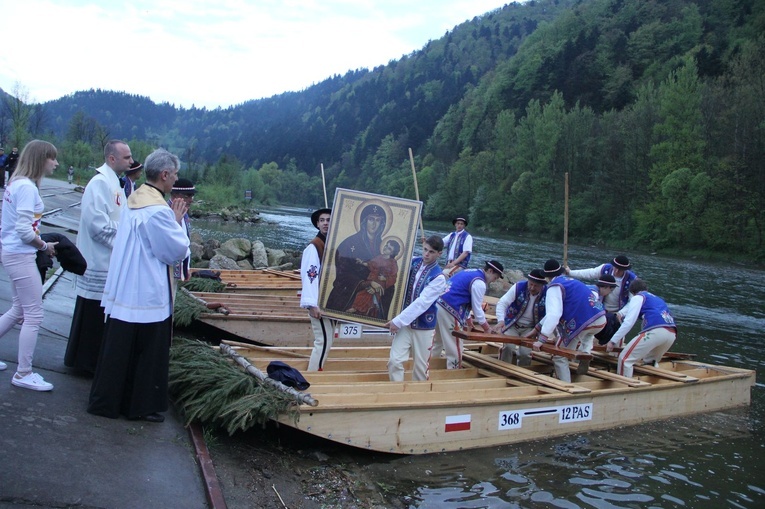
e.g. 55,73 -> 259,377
170,337 -> 300,435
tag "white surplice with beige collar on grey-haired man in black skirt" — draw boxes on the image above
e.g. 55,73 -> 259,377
101,185 -> 190,323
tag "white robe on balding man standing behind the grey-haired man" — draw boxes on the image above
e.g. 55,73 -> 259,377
75,164 -> 125,300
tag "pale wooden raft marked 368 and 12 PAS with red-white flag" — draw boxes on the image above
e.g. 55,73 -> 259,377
218,343 -> 755,454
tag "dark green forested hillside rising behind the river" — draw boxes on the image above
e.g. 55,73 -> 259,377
2,0 -> 765,261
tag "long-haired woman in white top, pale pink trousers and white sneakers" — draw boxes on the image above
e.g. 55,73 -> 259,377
0,140 -> 58,391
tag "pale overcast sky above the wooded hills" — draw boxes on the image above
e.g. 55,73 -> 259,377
0,0 -> 507,108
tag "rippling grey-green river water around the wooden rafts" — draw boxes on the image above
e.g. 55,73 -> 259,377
193,209 -> 765,509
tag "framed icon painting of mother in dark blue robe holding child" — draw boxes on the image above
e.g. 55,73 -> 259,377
319,189 -> 422,327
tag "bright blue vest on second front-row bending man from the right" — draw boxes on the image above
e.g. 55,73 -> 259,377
548,276 -> 606,346
